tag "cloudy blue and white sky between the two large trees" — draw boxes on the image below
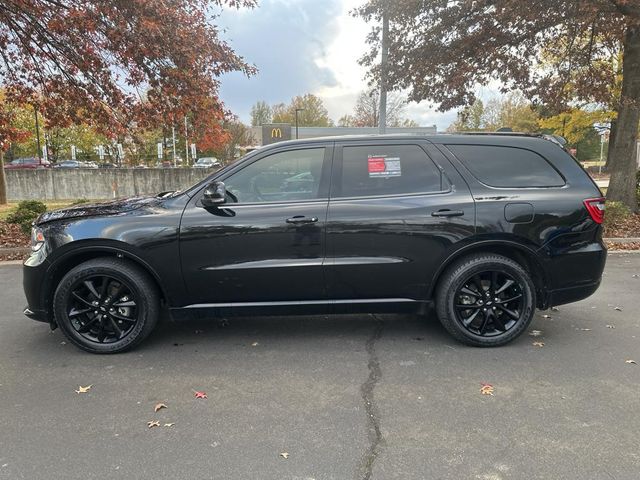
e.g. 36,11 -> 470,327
216,0 -> 456,130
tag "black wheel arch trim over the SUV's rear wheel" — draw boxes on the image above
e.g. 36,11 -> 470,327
428,240 -> 548,309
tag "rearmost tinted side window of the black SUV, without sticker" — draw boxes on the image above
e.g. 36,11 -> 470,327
447,145 -> 565,187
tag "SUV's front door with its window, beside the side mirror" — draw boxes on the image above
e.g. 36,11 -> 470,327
180,142 -> 333,304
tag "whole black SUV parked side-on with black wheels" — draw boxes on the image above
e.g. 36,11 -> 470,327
24,135 -> 606,353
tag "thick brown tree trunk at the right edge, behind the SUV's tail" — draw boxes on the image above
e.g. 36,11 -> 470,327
607,25 -> 640,212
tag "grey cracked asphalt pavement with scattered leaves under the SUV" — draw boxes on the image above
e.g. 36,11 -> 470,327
0,254 -> 640,480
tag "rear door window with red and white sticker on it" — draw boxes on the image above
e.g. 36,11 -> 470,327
336,145 -> 442,197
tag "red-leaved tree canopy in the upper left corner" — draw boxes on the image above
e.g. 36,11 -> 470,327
0,0 -> 256,201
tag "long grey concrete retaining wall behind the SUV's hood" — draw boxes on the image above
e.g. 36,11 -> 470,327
5,168 -> 213,201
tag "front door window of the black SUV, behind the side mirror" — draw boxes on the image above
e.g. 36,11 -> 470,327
225,147 -> 325,203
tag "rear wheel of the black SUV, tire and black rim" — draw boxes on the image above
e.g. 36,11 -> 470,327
436,253 -> 536,347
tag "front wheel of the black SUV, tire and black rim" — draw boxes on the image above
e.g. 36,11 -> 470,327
53,258 -> 160,353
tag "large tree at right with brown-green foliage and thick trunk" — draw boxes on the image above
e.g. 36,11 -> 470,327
357,0 -> 640,210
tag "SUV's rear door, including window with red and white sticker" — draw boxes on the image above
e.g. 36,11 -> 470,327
326,140 -> 475,303
